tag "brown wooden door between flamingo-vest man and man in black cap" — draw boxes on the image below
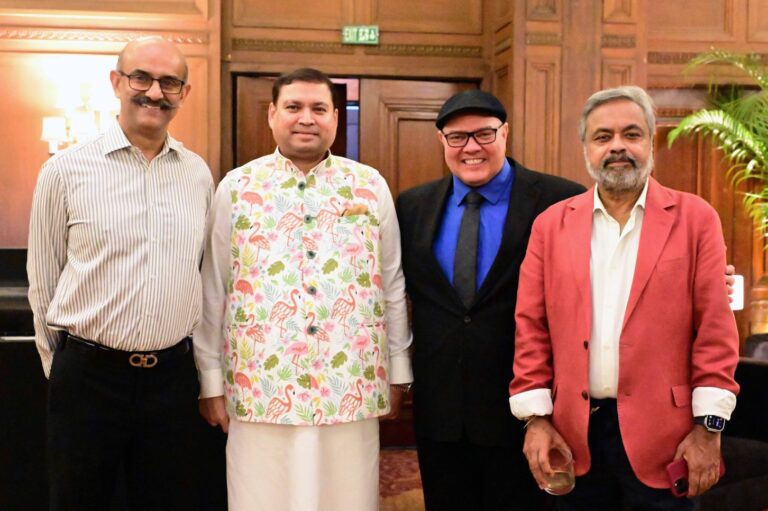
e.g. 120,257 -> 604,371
360,78 -> 477,196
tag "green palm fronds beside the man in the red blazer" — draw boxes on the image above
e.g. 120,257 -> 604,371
669,50 -> 768,233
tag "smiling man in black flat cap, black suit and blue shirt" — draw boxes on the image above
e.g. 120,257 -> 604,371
397,90 -> 584,511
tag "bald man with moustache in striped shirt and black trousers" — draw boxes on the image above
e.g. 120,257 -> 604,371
27,38 -> 213,510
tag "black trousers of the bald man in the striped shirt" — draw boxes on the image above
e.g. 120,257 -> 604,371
47,343 -> 199,511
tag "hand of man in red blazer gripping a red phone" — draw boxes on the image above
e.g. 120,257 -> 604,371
675,425 -> 720,497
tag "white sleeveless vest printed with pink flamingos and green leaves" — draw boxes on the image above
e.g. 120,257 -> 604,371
225,152 -> 389,426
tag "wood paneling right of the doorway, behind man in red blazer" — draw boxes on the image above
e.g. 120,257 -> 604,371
483,0 -> 768,344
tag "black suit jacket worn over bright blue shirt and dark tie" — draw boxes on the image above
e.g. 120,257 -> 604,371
397,159 -> 584,446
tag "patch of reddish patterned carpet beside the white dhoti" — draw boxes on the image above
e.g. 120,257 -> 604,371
379,449 -> 424,511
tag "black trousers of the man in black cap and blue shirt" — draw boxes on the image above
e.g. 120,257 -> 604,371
416,433 -> 552,511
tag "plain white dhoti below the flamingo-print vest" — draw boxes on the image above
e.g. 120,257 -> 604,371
227,419 -> 379,511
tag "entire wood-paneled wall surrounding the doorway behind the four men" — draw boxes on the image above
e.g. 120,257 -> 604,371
0,0 -> 768,338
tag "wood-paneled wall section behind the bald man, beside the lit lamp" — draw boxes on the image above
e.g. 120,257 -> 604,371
0,0 -> 221,248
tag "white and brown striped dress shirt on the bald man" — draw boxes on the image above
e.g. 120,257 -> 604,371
27,123 -> 213,377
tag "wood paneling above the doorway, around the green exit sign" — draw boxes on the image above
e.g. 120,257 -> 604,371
221,0 -> 488,172
